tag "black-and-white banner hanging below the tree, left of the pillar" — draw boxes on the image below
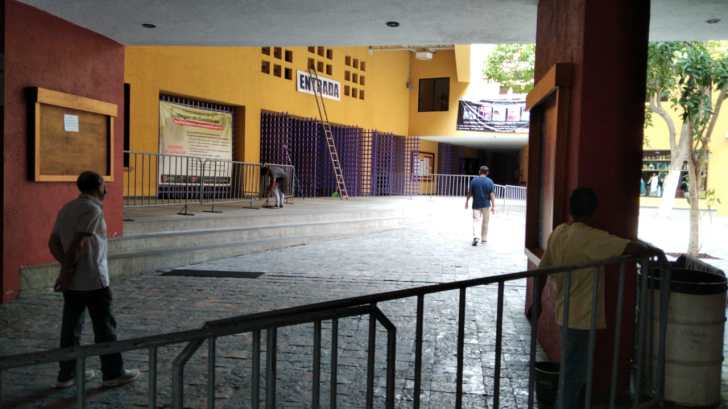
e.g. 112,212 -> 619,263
457,99 -> 528,132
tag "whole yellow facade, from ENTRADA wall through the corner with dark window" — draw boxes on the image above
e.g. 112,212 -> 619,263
125,45 -> 524,196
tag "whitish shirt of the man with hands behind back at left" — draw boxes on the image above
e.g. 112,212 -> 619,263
53,194 -> 109,291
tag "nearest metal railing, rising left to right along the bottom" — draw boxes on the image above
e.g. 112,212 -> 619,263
0,255 -> 670,409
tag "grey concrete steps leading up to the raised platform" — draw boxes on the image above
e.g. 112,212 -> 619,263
21,215 -> 405,292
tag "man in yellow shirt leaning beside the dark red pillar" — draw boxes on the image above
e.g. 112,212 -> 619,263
537,188 -> 655,409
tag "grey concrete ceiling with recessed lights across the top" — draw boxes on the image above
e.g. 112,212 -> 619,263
15,0 -> 728,45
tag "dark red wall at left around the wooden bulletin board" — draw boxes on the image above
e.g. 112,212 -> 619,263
2,0 -> 124,302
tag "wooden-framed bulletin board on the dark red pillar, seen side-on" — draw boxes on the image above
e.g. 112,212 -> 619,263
526,64 -> 572,265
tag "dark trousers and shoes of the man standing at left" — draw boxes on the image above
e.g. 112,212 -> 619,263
58,287 -> 124,381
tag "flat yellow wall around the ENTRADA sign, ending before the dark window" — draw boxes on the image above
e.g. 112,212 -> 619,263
125,46 -> 410,162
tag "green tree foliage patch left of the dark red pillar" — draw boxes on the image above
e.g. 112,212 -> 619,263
483,44 -> 536,93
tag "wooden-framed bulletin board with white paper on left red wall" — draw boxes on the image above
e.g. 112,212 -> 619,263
31,88 -> 117,182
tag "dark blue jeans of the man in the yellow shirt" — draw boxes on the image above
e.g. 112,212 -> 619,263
556,328 -> 589,409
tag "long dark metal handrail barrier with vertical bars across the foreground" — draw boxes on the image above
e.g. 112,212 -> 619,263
0,252 -> 670,409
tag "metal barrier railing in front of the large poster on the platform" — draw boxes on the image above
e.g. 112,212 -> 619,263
124,151 -> 295,214
